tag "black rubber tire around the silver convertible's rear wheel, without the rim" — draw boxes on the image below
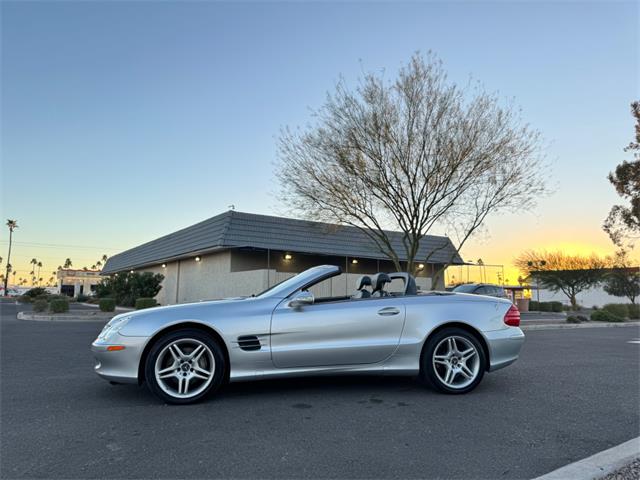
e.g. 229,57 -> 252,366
420,327 -> 487,395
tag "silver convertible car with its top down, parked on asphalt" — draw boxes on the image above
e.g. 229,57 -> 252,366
92,265 -> 524,404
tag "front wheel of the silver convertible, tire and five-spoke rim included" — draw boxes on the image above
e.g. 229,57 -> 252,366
145,329 -> 226,404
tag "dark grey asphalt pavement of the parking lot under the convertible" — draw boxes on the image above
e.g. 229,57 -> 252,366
0,303 -> 640,478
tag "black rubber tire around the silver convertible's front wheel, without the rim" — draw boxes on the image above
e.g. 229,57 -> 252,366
144,328 -> 227,405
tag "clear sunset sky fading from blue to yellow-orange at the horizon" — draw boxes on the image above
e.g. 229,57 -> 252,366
0,1 -> 639,283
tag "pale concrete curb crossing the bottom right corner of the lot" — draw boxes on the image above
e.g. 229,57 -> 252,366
534,437 -> 640,480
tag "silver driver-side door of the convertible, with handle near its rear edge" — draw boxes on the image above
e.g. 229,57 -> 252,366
270,297 -> 405,368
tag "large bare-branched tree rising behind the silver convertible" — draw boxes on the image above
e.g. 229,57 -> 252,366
276,54 -> 545,278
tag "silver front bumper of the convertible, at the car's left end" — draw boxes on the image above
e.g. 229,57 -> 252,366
91,334 -> 147,383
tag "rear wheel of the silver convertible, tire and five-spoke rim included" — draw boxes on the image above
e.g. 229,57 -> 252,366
421,327 -> 487,394
